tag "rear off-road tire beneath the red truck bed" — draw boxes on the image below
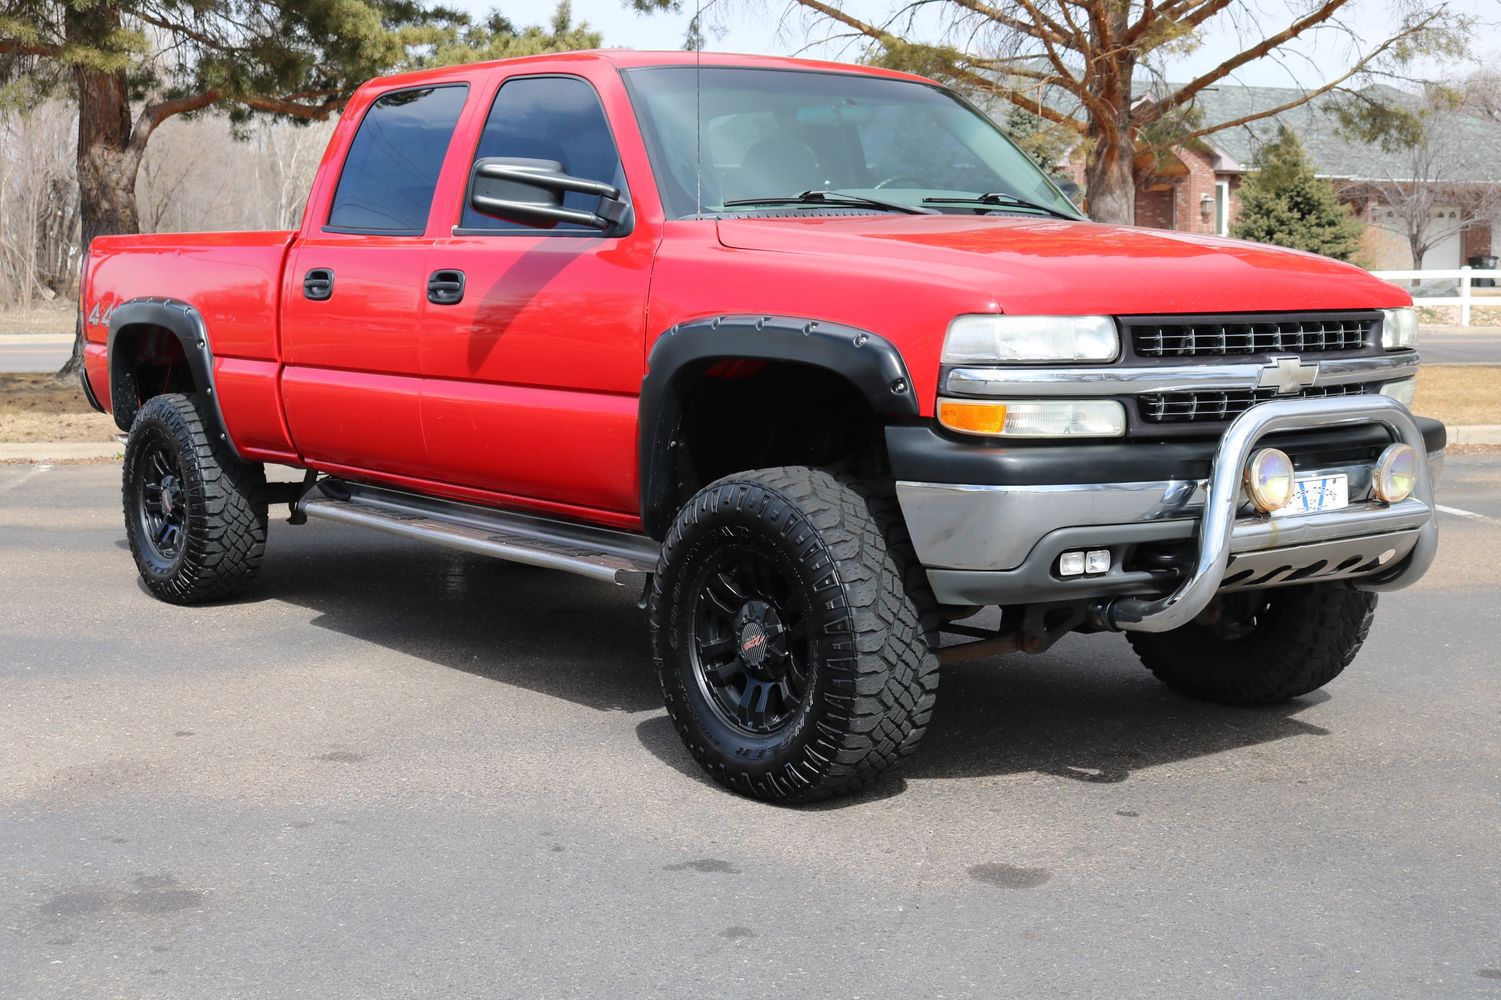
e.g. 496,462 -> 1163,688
122,393 -> 266,604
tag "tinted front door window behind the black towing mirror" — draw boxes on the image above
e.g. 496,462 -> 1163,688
462,77 -> 626,233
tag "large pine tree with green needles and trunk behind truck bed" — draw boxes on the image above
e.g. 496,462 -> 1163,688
0,0 -> 600,374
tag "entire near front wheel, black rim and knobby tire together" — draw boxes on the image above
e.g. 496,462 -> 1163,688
651,467 -> 938,800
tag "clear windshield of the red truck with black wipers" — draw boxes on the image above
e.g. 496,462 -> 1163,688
626,66 -> 1079,219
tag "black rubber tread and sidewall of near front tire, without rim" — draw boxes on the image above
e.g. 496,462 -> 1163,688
650,467 -> 938,802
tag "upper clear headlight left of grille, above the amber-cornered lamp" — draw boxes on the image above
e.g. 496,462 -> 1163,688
943,315 -> 1121,365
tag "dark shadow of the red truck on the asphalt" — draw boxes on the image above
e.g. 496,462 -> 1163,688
251,529 -> 1326,802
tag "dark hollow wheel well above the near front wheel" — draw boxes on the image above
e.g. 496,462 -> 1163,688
644,359 -> 889,535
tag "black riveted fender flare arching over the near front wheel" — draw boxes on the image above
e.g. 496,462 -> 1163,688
636,315 -> 920,539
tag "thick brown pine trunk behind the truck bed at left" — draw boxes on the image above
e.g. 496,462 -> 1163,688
57,5 -> 141,378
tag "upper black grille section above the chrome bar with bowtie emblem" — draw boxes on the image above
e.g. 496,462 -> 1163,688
1126,315 -> 1378,357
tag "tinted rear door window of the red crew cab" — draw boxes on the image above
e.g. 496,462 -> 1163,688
329,87 -> 468,233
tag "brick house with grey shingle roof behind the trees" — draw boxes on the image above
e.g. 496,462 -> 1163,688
1136,86 -> 1501,269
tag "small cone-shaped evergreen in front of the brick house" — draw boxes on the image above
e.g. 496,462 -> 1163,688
1231,128 -> 1361,260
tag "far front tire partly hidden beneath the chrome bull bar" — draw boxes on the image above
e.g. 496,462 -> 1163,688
1127,583 -> 1376,707
